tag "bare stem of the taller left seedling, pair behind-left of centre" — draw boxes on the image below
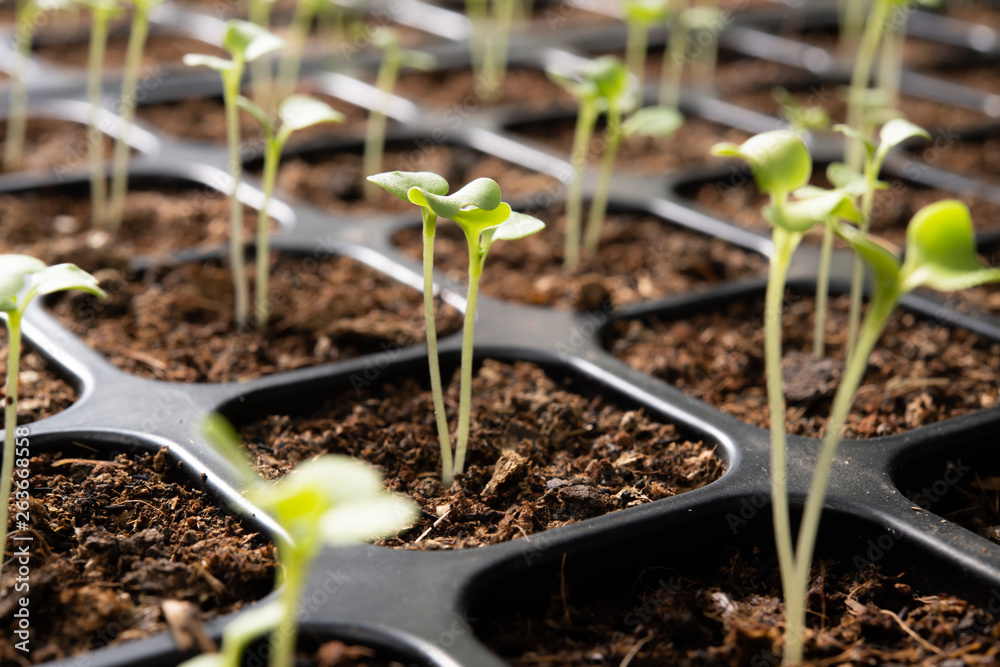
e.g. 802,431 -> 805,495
222,61 -> 250,329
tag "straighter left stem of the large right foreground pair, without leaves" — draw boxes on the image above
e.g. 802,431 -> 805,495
764,227 -> 802,664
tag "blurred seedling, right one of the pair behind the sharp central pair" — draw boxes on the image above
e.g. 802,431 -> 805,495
583,57 -> 684,254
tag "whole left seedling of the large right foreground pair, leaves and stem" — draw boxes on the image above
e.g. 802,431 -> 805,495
712,130 -> 857,661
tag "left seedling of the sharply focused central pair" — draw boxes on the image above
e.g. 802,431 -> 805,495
368,171 -> 455,487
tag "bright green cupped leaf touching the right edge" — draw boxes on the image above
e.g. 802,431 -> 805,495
900,199 -> 1000,292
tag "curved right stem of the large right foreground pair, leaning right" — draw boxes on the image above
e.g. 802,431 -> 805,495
783,294 -> 898,664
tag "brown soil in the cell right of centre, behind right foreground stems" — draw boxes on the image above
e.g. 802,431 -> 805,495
608,295 -> 1000,438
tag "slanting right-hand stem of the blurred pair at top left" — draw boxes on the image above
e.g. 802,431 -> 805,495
104,2 -> 149,229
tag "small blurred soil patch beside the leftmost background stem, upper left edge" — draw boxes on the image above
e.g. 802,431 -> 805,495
0,118 -> 113,173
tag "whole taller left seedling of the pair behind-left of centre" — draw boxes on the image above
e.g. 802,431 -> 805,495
184,19 -> 284,328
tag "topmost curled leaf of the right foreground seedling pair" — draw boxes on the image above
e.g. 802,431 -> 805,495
712,130 -> 812,195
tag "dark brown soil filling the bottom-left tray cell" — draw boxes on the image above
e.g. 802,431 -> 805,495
0,450 -> 275,665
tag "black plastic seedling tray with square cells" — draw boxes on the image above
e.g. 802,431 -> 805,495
0,3 -> 1000,667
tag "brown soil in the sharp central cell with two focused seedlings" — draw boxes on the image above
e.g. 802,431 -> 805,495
241,360 -> 723,549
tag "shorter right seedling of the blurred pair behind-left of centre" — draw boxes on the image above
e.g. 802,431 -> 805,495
237,95 -> 344,328
